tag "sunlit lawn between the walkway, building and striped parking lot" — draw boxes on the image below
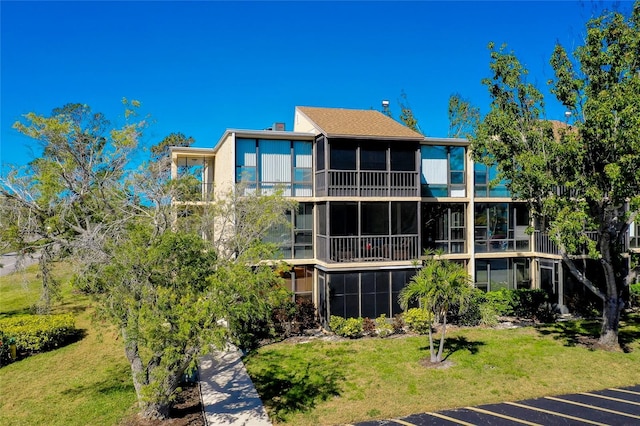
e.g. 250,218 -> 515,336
245,314 -> 640,425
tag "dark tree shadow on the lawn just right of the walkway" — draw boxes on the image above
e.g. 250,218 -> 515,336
245,354 -> 344,421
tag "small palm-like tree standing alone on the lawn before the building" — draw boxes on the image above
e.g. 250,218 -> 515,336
398,251 -> 473,363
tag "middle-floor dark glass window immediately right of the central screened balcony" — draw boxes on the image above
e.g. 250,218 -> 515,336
422,203 -> 467,253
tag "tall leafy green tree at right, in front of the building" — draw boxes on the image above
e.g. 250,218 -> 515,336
472,2 -> 640,347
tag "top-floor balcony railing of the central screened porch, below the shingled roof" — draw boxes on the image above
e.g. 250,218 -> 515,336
316,170 -> 420,197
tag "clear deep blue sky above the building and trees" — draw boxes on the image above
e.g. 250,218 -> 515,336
0,1 -> 631,170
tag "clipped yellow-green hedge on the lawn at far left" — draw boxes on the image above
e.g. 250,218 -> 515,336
0,314 -> 78,352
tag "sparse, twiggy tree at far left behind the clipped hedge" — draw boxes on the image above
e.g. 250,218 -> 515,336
0,99 -> 145,312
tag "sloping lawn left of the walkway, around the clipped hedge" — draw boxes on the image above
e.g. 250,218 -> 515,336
0,265 -> 135,425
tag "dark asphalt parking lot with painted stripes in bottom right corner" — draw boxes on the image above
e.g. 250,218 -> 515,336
357,385 -> 640,426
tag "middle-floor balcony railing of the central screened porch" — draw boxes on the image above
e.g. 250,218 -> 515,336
318,235 -> 420,263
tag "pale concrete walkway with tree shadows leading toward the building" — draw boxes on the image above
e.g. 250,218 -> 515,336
198,346 -> 271,426
